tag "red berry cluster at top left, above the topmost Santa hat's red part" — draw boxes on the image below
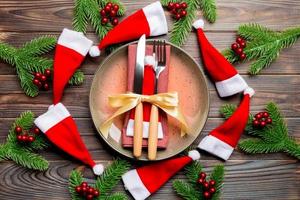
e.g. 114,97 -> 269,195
100,2 -> 119,26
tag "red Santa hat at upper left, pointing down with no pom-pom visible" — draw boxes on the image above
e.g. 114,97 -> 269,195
53,28 -> 93,104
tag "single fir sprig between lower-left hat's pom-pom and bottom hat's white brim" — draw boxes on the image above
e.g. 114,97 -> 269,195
95,159 -> 129,194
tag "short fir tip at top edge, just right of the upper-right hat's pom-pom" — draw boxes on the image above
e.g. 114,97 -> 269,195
200,0 -> 217,23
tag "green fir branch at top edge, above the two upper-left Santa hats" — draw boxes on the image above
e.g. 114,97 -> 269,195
73,0 -> 125,39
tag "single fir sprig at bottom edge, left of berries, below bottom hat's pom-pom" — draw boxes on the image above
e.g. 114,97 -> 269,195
173,180 -> 202,200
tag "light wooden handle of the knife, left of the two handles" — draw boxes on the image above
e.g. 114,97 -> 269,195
133,103 -> 143,158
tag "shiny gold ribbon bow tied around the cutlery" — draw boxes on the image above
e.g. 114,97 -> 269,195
100,92 -> 188,138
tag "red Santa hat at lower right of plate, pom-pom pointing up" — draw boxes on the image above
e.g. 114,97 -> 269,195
198,88 -> 254,160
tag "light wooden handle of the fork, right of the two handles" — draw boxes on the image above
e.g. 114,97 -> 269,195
148,105 -> 158,160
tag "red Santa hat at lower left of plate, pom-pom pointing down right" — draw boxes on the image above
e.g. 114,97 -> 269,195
34,103 -> 104,175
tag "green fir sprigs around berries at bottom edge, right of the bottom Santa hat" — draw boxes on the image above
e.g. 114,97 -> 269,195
173,161 -> 224,200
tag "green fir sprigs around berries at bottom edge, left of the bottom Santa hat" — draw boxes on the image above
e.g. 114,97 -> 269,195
69,159 -> 129,200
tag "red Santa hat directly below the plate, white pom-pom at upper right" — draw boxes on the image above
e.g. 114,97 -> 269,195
122,150 -> 200,200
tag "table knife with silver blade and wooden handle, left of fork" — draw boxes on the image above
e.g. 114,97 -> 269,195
133,34 -> 146,158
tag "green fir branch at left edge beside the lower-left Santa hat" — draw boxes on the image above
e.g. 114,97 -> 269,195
0,111 -> 49,171
